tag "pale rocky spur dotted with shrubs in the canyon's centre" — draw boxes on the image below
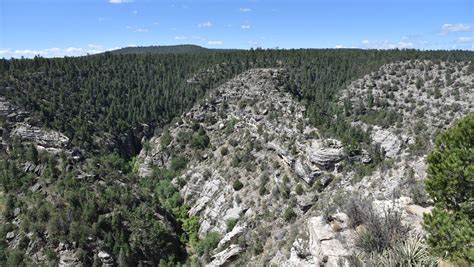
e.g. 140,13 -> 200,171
140,69 -> 352,265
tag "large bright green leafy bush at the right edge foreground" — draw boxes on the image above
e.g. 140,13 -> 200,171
424,114 -> 474,262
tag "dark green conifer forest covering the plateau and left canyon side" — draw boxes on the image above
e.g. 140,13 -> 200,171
0,49 -> 474,266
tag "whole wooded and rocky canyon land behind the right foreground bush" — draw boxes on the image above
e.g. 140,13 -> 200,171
0,47 -> 474,266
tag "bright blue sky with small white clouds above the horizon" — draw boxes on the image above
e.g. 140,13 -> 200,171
0,0 -> 474,58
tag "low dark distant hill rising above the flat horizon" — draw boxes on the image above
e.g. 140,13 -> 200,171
105,44 -> 236,55
